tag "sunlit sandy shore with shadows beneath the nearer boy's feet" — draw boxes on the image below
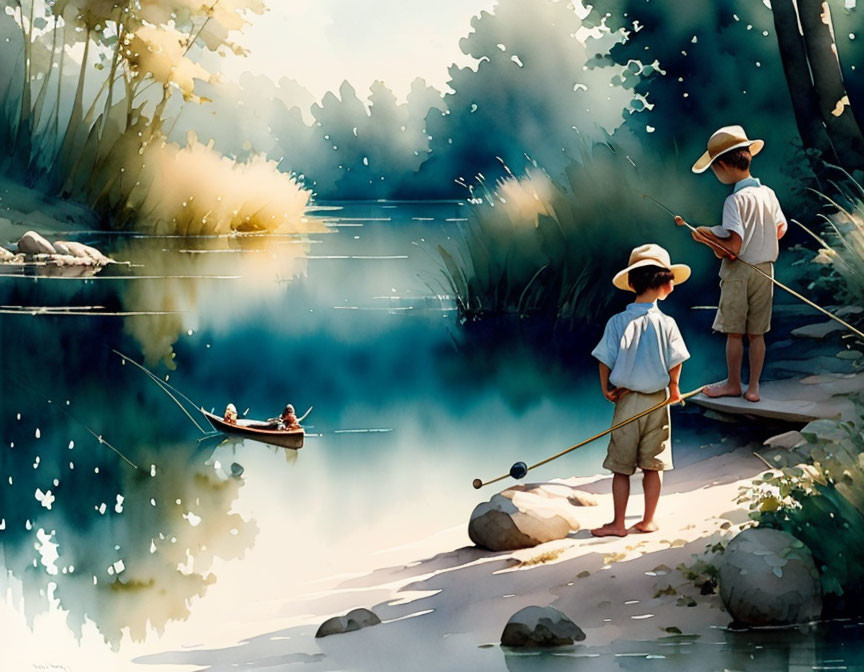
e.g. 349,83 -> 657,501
136,446 -> 765,670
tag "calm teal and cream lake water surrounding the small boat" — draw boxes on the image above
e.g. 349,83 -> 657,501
0,202 -> 808,656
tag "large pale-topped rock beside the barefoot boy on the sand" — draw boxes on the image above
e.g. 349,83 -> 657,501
468,483 -> 597,551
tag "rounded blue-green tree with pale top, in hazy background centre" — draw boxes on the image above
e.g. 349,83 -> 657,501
423,0 -> 633,192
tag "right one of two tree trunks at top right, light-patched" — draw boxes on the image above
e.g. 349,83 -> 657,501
798,0 -> 864,171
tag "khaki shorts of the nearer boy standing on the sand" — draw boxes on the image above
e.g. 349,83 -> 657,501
603,390 -> 672,476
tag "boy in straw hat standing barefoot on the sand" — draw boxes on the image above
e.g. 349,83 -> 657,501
591,243 -> 690,537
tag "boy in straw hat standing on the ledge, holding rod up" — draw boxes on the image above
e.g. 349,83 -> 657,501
675,126 -> 788,402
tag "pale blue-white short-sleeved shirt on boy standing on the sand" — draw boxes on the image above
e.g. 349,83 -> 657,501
591,303 -> 690,394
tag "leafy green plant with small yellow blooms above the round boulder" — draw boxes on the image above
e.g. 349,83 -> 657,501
738,410 -> 864,614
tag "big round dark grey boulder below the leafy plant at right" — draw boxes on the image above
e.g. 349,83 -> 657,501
719,527 -> 822,626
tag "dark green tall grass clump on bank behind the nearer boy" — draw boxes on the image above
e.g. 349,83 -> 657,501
438,145 -> 700,326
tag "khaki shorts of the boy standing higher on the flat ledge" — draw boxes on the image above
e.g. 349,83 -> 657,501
712,259 -> 774,334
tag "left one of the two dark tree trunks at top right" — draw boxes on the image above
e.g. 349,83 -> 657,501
771,0 -> 839,167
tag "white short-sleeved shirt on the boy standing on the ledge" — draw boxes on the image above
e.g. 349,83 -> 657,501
711,177 -> 788,264
